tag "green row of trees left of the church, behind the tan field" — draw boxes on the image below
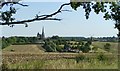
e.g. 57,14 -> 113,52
2,36 -> 38,49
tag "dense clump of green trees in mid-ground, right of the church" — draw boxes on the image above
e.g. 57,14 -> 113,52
44,39 -> 92,53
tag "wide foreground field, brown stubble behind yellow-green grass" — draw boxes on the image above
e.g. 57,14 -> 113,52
3,53 -> 118,69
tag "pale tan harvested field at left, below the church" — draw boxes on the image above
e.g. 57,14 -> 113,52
3,44 -> 44,53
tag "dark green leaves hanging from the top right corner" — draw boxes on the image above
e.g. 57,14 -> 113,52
70,0 -> 120,42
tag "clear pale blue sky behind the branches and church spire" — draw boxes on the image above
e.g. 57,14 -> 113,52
0,0 -> 118,37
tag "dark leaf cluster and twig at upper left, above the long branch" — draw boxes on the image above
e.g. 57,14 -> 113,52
0,0 -> 27,27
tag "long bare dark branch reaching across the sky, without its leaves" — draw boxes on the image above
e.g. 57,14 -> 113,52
0,3 -> 70,25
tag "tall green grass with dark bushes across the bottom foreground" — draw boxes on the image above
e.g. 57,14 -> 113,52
2,54 -> 118,69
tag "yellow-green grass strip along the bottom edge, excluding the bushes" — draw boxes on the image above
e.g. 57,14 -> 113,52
8,58 -> 118,69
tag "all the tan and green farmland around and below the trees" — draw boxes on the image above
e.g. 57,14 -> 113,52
2,42 -> 118,69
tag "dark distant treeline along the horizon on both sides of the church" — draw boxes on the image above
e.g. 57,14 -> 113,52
2,36 -> 117,48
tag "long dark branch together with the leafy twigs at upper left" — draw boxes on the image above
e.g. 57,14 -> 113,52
0,0 -> 70,27
